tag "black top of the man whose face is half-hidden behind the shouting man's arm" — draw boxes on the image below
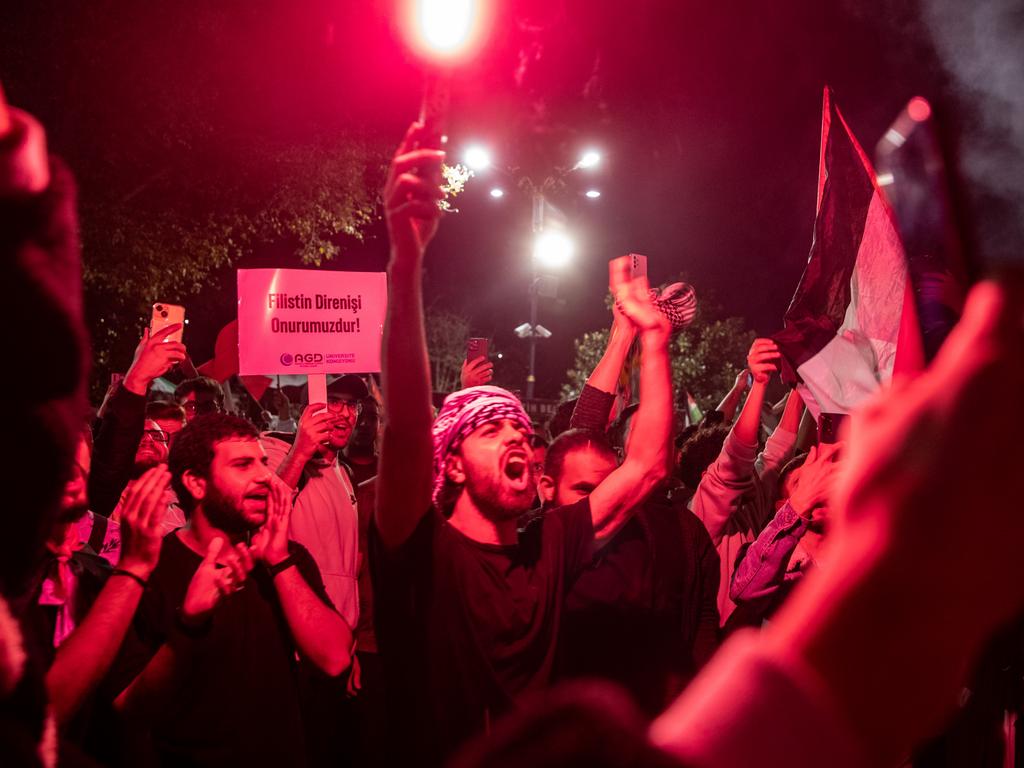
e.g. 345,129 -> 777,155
558,499 -> 719,717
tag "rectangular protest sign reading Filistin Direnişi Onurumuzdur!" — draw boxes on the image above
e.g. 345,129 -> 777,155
239,269 -> 387,375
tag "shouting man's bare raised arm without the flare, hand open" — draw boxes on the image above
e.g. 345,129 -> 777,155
590,257 -> 672,542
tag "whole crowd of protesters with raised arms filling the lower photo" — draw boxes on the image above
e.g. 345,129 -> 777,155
0,83 -> 1024,766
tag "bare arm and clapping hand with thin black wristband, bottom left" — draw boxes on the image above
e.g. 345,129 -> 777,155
46,467 -> 170,724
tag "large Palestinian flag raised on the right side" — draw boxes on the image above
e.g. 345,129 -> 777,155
774,88 -> 914,418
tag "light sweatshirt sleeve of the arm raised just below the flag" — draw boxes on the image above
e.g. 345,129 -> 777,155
690,432 -> 758,547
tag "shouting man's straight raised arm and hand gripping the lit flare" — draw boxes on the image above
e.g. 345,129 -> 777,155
374,123 -> 444,547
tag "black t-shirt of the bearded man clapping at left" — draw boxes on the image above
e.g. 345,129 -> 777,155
112,532 -> 331,765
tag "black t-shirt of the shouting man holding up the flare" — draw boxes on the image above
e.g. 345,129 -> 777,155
371,500 -> 594,764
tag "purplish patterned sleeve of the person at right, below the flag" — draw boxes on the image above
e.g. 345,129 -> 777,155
729,504 -> 807,605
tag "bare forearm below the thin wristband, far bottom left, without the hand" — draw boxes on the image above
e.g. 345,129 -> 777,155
46,577 -> 142,725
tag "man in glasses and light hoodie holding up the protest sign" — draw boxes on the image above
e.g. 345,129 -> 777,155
262,374 -> 370,627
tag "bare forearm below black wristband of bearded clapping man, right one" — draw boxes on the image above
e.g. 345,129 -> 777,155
273,566 -> 352,677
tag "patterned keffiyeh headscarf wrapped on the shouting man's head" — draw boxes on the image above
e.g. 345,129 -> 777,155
431,386 -> 534,507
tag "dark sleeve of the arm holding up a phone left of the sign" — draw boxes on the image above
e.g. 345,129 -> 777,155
89,386 -> 145,517
